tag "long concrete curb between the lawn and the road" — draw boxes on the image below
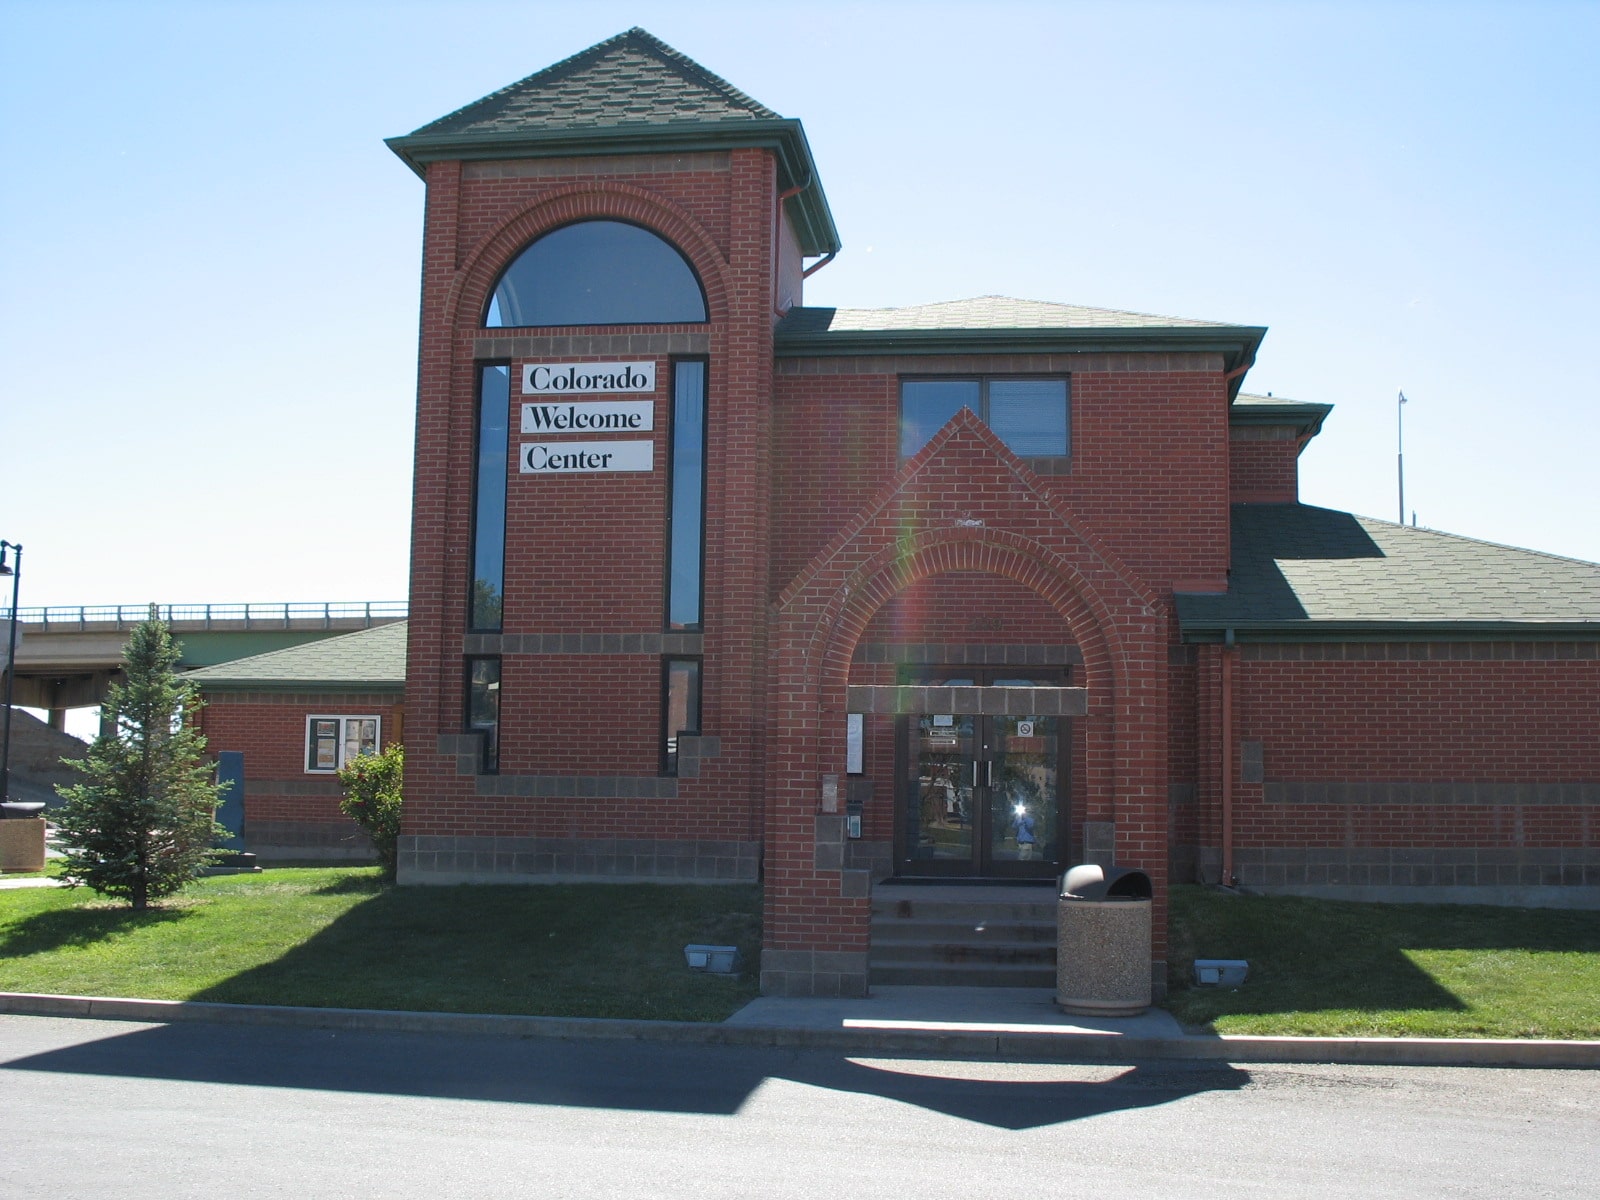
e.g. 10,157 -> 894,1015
0,992 -> 1600,1069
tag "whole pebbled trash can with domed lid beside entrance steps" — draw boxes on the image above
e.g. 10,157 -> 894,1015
1056,862 -> 1155,1016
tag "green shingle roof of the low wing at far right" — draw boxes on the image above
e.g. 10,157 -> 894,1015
1178,504 -> 1600,637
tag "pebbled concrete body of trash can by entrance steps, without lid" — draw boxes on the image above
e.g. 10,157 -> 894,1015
1056,898 -> 1150,1016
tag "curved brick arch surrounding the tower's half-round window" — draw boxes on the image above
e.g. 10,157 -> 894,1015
445,184 -> 728,328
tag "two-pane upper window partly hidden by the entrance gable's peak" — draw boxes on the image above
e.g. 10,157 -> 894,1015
901,376 -> 1072,459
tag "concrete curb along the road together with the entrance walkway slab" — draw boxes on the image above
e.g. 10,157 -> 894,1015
0,987 -> 1600,1067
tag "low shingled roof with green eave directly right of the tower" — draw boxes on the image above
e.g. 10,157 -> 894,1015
774,296 -> 1267,392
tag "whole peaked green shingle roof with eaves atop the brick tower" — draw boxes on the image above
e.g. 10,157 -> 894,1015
387,27 -> 838,254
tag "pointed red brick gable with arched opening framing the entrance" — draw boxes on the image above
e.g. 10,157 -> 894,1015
762,414 -> 1168,995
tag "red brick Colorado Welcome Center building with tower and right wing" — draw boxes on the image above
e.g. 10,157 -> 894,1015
353,30 -> 1600,994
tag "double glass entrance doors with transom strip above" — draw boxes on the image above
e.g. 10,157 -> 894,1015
896,667 -> 1066,878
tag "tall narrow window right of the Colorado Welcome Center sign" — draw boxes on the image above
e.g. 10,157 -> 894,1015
667,358 -> 706,630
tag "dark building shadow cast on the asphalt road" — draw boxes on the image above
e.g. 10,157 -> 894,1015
0,1022 -> 1251,1130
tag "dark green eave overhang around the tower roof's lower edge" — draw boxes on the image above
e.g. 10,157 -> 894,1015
384,117 -> 840,258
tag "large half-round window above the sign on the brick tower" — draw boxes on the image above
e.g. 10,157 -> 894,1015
483,221 -> 706,328
